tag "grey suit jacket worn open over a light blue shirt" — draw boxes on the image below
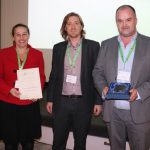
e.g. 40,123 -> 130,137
93,33 -> 150,124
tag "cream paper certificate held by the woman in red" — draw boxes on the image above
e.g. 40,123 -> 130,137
15,68 -> 42,100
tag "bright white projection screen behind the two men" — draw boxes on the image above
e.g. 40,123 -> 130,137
28,0 -> 150,49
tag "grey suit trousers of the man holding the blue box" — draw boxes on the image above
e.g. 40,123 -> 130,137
107,108 -> 150,150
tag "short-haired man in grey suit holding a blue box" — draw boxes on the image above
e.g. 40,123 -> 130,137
93,5 -> 150,150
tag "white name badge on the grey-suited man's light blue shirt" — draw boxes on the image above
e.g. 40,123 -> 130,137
117,71 -> 130,82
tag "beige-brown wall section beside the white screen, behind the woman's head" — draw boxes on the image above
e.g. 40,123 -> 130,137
0,0 -> 28,48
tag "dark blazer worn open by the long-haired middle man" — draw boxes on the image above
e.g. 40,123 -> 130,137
47,39 -> 101,111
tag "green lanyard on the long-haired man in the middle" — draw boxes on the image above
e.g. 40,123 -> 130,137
67,44 -> 81,68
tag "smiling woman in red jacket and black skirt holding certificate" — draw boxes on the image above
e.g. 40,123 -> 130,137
0,24 -> 45,150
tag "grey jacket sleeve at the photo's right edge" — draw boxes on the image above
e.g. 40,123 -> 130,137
132,34 -> 150,102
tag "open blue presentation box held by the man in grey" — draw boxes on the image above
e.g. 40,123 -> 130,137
106,82 -> 131,100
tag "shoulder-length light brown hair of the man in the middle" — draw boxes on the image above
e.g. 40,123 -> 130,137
60,12 -> 85,40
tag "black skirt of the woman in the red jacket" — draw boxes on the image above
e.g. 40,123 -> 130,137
0,100 -> 41,143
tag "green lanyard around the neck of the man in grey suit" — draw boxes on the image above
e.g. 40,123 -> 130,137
119,40 -> 136,64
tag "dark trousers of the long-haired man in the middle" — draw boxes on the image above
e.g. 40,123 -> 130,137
52,97 -> 91,150
